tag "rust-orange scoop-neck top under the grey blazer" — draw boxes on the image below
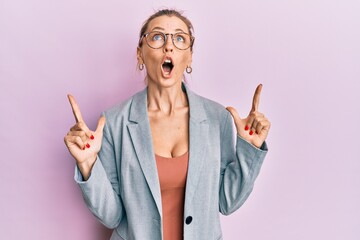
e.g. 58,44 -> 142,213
155,152 -> 189,240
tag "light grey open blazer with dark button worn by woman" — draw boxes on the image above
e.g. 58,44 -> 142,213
75,85 -> 267,240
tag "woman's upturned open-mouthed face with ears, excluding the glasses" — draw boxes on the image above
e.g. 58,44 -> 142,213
137,16 -> 192,87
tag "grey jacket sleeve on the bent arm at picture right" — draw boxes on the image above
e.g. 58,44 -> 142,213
219,112 -> 267,215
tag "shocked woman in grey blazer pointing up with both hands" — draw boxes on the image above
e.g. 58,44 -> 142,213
65,10 -> 270,240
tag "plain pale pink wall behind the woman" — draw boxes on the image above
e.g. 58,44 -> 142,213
0,0 -> 360,240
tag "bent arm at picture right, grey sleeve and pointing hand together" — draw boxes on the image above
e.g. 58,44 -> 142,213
219,85 -> 270,215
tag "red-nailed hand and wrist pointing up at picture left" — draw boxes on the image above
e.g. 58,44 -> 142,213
64,94 -> 105,180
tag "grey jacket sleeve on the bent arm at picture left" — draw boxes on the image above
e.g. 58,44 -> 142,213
74,114 -> 124,228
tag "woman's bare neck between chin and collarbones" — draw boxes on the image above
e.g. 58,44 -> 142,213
147,82 -> 188,116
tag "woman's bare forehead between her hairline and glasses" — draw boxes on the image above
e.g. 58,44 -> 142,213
147,16 -> 189,33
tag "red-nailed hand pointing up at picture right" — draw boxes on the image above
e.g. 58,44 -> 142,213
226,84 -> 271,148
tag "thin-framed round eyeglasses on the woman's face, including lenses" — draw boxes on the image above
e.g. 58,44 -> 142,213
139,31 -> 195,50
